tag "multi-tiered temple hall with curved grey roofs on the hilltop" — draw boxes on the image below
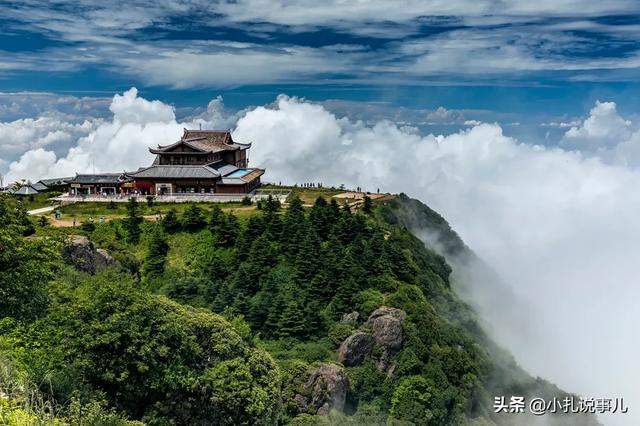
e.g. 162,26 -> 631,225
126,129 -> 264,195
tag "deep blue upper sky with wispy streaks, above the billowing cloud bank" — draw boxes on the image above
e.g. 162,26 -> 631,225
0,0 -> 640,115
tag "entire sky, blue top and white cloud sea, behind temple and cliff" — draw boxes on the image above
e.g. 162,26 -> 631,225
0,0 -> 640,424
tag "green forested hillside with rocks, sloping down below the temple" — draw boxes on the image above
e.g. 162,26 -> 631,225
0,191 -> 597,425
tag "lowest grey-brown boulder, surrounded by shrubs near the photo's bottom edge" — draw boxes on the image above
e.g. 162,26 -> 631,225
305,364 -> 349,416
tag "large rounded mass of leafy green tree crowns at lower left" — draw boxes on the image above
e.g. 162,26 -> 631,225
16,271 -> 280,425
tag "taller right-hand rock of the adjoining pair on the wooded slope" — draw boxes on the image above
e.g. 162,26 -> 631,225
365,306 -> 407,374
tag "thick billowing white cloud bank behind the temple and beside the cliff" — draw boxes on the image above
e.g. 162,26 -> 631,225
2,89 -> 640,424
